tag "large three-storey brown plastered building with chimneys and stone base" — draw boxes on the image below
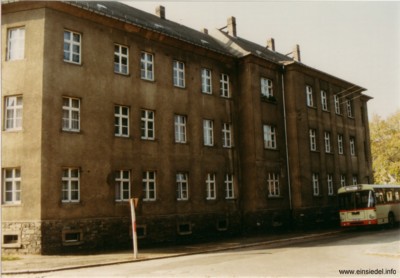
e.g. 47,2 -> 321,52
1,1 -> 372,254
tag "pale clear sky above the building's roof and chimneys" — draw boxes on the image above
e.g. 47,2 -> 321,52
122,0 -> 400,119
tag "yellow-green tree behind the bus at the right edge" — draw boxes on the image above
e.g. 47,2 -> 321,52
370,110 -> 400,184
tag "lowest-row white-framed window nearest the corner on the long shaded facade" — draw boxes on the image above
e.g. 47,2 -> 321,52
61,168 -> 80,203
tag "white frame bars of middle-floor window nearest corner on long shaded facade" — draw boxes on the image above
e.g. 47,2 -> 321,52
62,96 -> 81,132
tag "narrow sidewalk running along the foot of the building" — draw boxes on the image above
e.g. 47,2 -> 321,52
2,229 -> 342,275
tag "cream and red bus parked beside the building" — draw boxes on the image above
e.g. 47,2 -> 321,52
338,184 -> 400,227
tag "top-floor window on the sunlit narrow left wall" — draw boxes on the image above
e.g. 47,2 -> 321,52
7,27 -> 25,61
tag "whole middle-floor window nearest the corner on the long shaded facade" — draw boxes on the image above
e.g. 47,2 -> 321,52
62,97 -> 80,132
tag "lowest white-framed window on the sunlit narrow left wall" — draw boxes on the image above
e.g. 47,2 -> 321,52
3,168 -> 21,204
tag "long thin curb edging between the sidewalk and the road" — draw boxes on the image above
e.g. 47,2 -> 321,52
1,230 -> 343,275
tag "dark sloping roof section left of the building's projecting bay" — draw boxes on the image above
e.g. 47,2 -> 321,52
63,1 -> 231,56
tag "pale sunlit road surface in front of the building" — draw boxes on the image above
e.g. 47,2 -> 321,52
7,229 -> 400,278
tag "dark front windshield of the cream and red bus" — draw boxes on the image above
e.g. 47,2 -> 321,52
339,190 -> 375,210
